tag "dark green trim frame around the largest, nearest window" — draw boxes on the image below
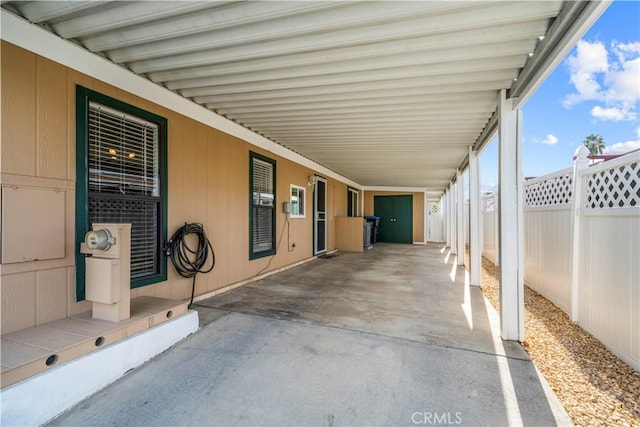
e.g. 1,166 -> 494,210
75,85 -> 168,301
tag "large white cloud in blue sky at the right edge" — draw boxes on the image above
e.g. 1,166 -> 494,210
562,40 -> 640,121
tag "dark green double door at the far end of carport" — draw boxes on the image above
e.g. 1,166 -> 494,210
373,195 -> 413,243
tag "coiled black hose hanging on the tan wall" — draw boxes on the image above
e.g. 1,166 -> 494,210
166,223 -> 216,308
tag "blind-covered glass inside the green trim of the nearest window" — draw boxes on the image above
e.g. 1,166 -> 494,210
87,102 -> 161,280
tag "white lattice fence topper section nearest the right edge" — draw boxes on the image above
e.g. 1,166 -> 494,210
584,161 -> 640,209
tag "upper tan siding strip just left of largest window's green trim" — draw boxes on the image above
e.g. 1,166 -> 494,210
36,57 -> 68,179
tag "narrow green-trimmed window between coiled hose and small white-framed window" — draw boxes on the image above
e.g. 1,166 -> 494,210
249,152 -> 276,259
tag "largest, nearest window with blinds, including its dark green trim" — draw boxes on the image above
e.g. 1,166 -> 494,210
76,86 -> 167,299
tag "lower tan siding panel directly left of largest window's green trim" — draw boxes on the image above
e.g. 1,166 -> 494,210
36,267 -> 67,325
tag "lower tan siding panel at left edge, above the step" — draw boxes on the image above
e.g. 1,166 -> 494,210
0,272 -> 36,335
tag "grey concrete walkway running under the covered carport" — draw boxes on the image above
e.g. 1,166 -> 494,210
52,244 -> 570,426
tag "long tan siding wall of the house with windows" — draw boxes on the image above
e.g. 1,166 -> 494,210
1,41 -> 364,333
